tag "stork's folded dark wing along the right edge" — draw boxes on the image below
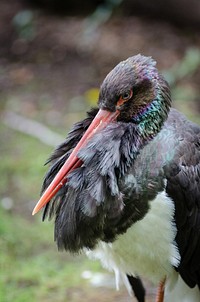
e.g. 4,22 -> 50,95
166,113 -> 200,287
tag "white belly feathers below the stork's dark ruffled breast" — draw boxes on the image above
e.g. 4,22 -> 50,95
87,192 -> 180,283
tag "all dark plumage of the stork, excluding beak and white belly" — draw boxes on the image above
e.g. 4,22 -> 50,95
34,56 -> 200,300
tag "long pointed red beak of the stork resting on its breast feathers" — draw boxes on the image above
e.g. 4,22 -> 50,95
32,109 -> 119,215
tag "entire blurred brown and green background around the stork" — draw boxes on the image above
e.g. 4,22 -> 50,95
0,0 -> 200,302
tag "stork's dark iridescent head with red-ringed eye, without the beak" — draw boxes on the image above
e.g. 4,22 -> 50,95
98,55 -> 171,123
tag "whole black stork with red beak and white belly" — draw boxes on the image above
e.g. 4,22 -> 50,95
33,55 -> 200,302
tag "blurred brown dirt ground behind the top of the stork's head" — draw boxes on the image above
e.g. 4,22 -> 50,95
0,0 -> 200,110
